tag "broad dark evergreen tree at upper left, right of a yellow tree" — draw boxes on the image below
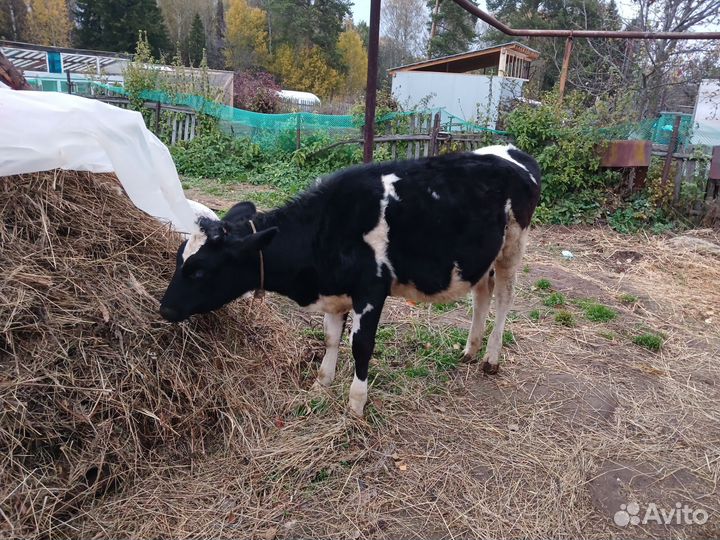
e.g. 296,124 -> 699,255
75,0 -> 169,56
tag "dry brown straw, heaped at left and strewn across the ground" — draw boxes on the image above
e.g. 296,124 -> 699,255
0,172 -> 720,539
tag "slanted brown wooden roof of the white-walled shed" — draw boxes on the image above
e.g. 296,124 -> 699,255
388,41 -> 540,73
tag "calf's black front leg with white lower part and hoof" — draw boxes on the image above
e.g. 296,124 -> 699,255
348,296 -> 385,416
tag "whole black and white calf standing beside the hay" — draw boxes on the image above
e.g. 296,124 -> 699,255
160,146 -> 540,415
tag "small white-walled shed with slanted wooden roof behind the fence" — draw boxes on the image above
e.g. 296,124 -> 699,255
389,41 -> 540,127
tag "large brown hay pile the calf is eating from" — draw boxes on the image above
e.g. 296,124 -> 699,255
0,171 -> 302,538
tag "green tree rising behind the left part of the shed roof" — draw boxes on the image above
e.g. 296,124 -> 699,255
427,0 -> 478,58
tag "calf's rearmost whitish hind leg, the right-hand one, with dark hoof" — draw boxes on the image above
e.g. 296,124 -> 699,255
483,224 -> 528,375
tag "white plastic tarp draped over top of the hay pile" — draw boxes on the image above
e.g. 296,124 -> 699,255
0,87 -> 196,232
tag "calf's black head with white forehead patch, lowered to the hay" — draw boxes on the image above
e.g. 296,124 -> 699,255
160,203 -> 277,322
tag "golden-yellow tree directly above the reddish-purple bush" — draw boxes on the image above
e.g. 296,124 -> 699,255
226,0 -> 268,69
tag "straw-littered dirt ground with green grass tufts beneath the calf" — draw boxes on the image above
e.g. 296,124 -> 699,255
105,187 -> 720,539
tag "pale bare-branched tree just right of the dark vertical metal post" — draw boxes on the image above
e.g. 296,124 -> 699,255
380,0 -> 427,65
